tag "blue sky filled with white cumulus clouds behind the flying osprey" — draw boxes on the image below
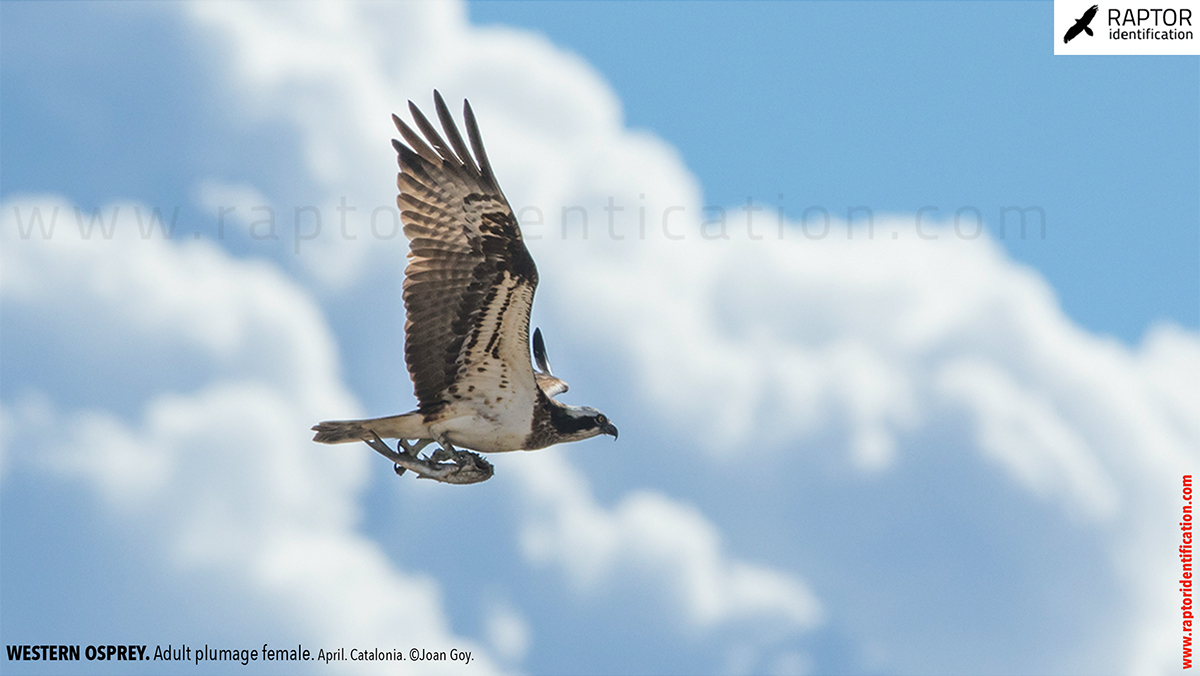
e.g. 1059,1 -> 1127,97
0,2 -> 1200,674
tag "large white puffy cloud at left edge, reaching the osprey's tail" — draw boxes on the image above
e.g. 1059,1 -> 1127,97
0,197 -> 491,671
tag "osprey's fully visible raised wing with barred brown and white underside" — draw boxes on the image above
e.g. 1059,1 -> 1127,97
392,91 -> 538,413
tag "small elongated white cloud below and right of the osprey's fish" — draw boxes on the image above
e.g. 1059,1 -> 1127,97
509,453 -> 821,634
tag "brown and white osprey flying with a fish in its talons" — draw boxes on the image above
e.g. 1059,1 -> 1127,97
313,91 -> 617,484
